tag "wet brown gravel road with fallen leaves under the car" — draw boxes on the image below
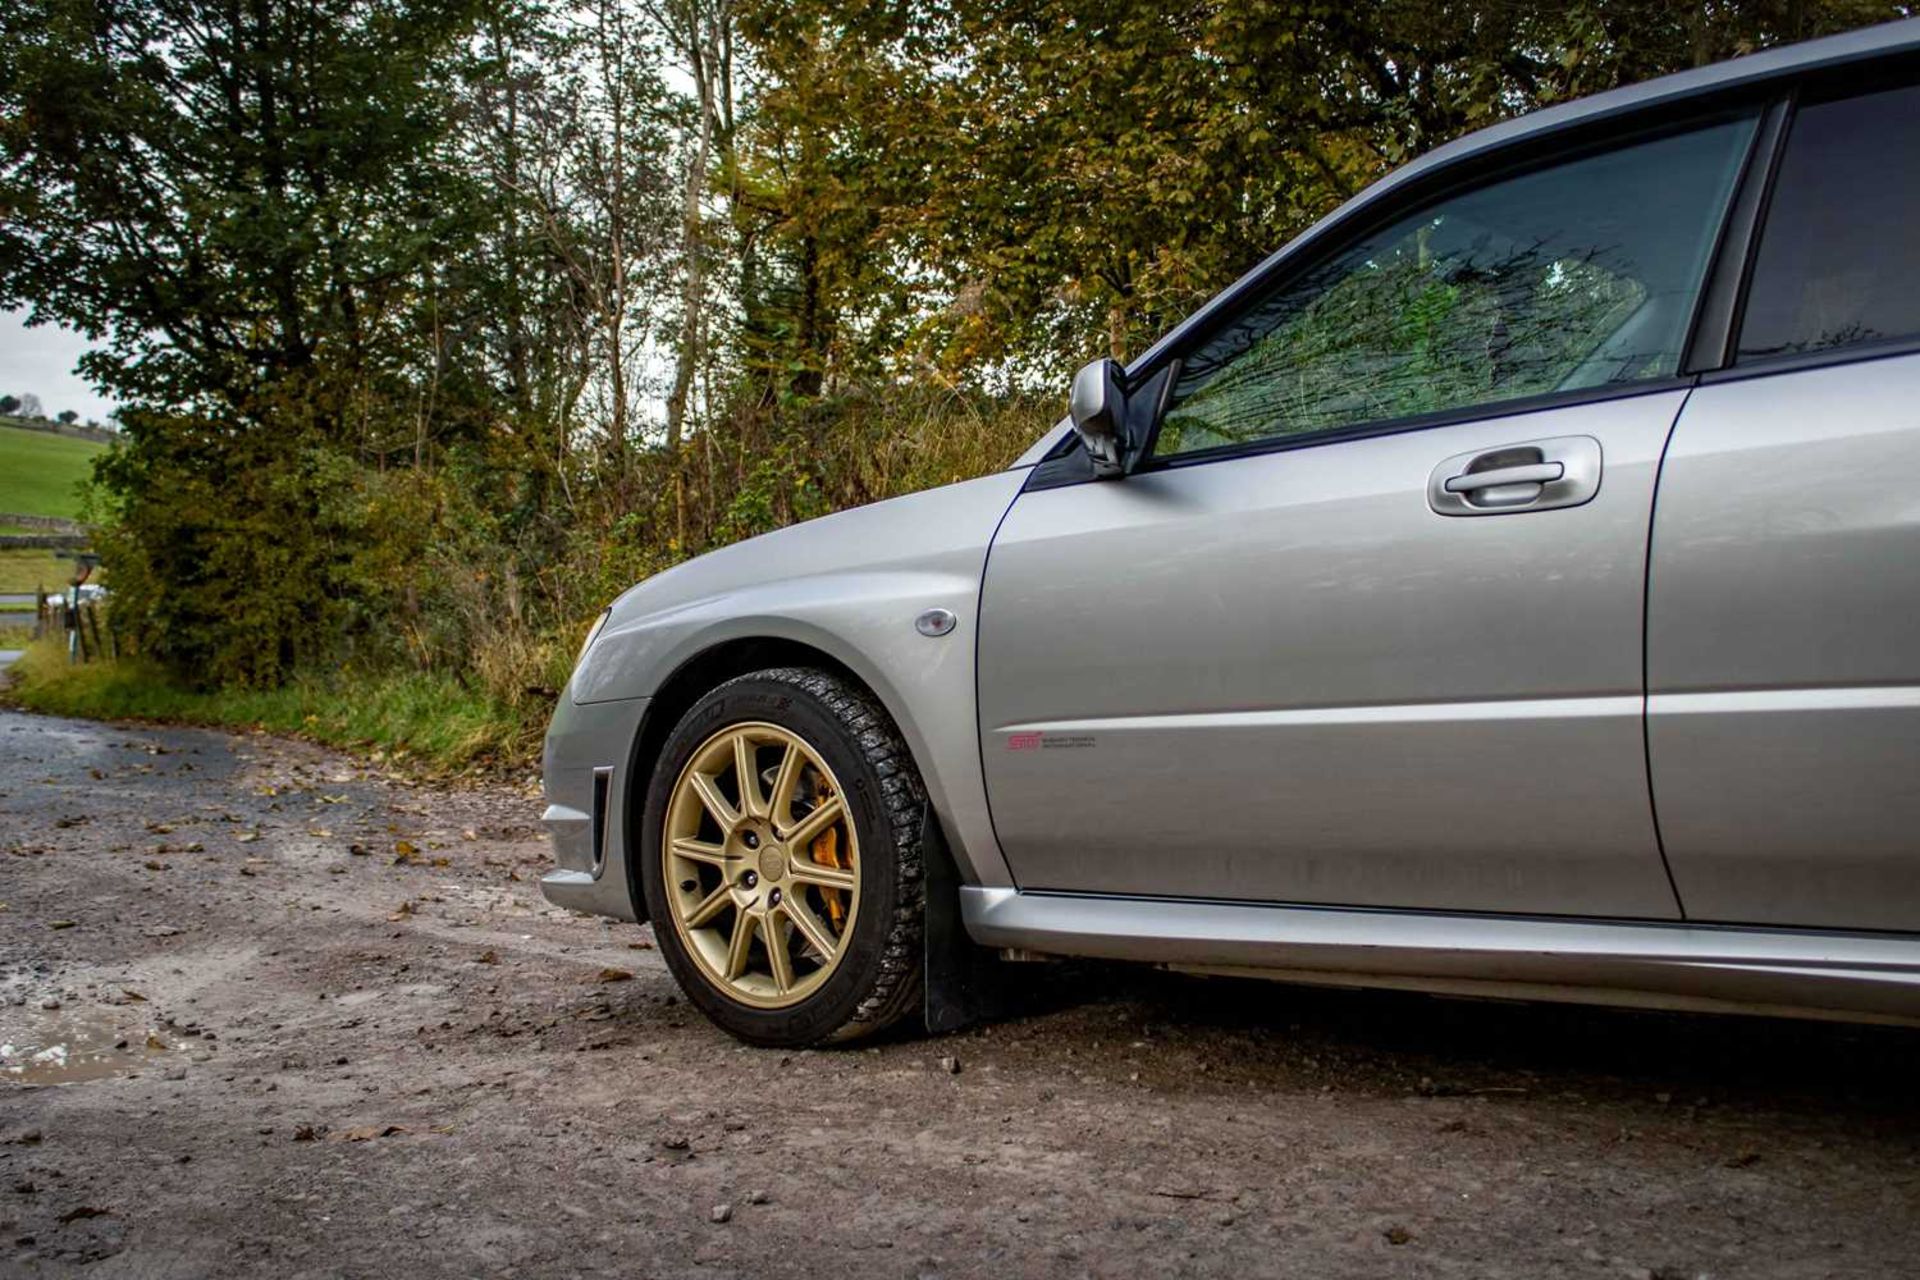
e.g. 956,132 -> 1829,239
0,714 -> 1920,1280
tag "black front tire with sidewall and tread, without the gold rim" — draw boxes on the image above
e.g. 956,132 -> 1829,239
639,668 -> 925,1048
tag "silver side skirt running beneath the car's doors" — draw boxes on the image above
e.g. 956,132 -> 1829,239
960,887 -> 1920,1023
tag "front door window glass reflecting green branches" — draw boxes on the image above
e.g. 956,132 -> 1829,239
1154,121 -> 1753,457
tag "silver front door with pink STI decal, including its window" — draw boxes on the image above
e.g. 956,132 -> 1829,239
979,110 -> 1751,917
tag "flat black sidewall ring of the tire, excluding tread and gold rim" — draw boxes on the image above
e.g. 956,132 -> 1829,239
639,674 -> 900,1044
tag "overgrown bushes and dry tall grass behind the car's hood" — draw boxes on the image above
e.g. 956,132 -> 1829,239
82,379 -> 1052,754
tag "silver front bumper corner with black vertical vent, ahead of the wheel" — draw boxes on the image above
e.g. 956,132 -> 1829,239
540,697 -> 647,921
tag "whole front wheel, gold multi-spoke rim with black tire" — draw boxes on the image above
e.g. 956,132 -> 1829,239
639,668 -> 925,1046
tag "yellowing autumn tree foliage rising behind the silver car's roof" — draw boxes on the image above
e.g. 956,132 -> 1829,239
743,0 -> 1901,378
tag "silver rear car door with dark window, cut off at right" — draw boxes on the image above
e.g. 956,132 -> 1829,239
1647,77 -> 1920,931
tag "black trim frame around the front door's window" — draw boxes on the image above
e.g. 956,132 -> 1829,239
1128,102 -> 1780,475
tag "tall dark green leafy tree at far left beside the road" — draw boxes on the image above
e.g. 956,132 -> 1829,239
0,0 -> 492,683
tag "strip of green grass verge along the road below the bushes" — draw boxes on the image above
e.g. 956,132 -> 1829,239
0,641 -> 545,775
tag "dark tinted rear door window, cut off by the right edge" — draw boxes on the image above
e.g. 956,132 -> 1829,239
1740,86 -> 1920,361
